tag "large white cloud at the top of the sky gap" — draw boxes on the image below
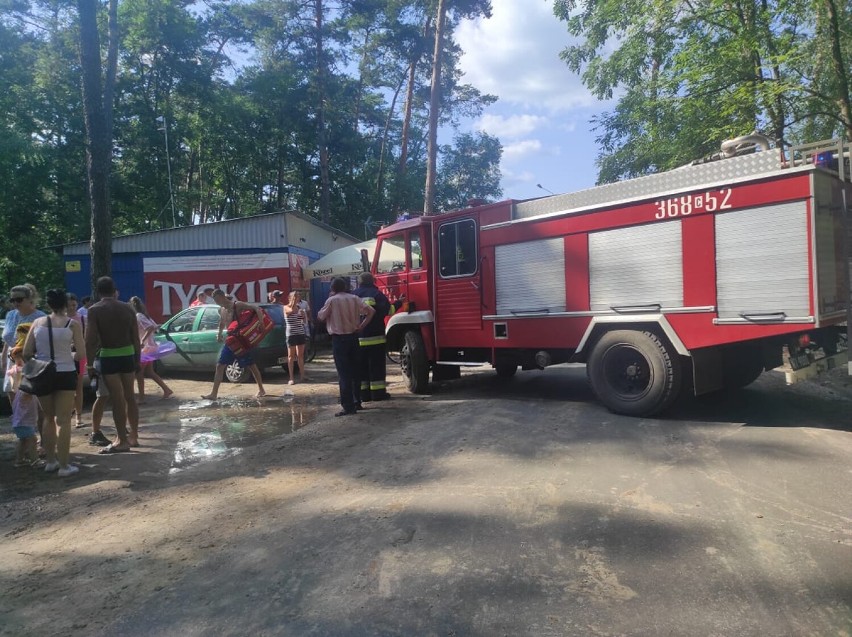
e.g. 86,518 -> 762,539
455,0 -> 595,112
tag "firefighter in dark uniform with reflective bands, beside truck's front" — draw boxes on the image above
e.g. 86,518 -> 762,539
352,272 -> 390,402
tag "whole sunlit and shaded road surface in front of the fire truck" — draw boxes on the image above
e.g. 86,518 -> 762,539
0,359 -> 852,636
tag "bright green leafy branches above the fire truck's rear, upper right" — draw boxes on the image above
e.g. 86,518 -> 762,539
554,0 -> 852,182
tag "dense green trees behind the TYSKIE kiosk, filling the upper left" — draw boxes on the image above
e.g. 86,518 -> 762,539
0,0 -> 506,288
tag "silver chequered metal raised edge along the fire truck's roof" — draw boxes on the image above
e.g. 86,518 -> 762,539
512,140 -> 852,219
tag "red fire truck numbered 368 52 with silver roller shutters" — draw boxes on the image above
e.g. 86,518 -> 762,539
372,135 -> 852,416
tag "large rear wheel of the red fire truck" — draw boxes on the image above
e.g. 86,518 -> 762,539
587,330 -> 683,416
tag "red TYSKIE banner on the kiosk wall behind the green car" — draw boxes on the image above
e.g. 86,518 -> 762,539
143,252 -> 290,322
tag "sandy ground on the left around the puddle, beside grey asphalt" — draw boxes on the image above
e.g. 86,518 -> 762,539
0,356 -> 406,636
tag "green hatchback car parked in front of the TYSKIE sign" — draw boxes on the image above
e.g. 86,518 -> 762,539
154,303 -> 287,383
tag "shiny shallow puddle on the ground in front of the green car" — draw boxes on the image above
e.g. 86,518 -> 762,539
169,394 -> 317,474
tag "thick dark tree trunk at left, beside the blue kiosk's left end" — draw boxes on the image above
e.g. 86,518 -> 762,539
77,0 -> 112,290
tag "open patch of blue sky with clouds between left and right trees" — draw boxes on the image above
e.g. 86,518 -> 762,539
456,0 -> 609,199
